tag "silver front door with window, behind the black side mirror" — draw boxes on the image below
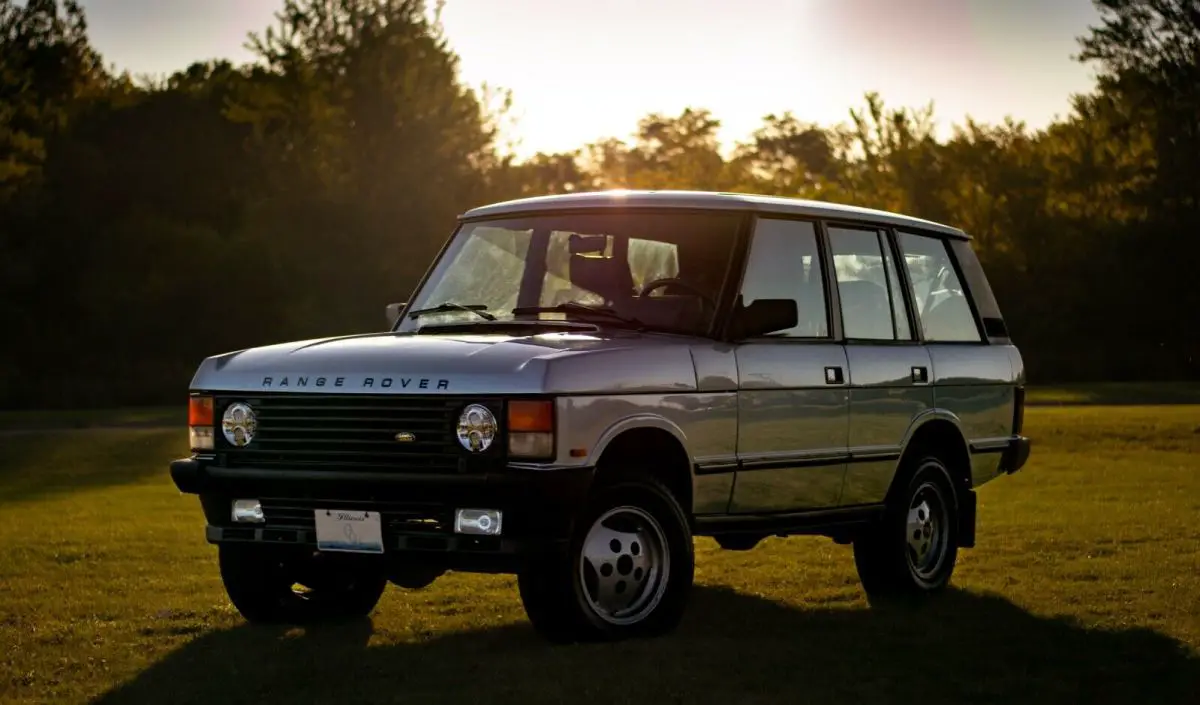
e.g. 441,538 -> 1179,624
730,218 -> 850,513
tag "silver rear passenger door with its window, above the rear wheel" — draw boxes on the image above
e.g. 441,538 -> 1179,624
827,223 -> 934,506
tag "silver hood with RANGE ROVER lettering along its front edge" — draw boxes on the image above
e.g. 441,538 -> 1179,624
191,331 -> 696,394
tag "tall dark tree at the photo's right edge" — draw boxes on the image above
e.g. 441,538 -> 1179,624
1079,0 -> 1200,374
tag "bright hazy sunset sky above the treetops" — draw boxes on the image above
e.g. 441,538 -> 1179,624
82,0 -> 1098,157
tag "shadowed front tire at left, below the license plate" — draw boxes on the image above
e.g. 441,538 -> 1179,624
218,543 -> 388,625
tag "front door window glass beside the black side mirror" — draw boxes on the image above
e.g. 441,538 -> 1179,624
742,218 -> 829,338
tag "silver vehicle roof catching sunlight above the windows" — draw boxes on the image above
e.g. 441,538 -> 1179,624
461,191 -> 970,240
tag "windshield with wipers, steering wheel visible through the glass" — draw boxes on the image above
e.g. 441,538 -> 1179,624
397,211 -> 740,335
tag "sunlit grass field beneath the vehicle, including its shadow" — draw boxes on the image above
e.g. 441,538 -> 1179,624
0,397 -> 1200,705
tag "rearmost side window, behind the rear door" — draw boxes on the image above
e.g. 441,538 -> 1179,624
898,233 -> 983,343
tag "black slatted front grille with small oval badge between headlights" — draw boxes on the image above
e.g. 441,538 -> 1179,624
216,394 -> 489,472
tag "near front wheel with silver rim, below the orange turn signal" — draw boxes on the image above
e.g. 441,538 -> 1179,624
517,478 -> 695,643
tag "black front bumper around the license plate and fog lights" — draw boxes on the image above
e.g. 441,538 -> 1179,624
170,458 -> 593,572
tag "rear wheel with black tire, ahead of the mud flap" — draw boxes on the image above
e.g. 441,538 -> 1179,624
854,456 -> 959,599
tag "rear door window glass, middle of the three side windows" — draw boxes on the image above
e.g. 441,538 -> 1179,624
829,227 -> 912,341
